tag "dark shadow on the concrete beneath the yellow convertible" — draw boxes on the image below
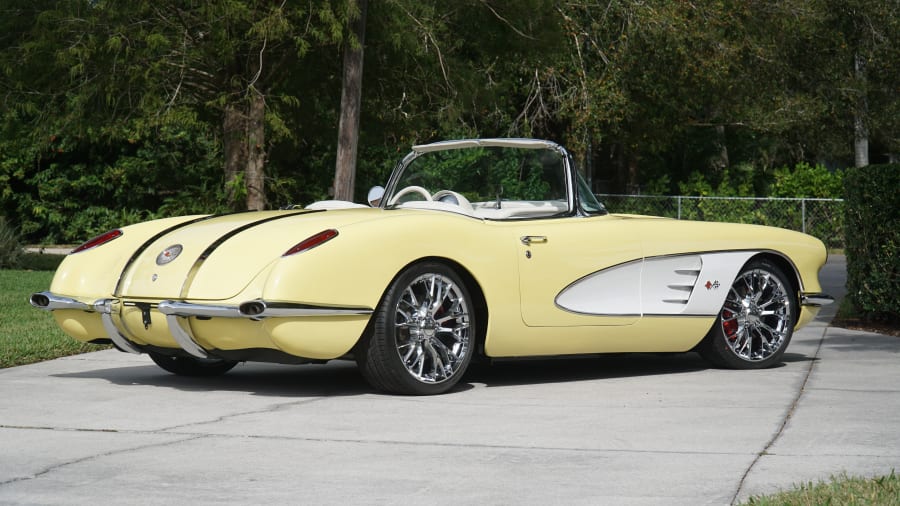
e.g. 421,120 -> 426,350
56,353 -> 816,397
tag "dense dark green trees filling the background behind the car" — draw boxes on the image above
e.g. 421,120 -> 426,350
0,0 -> 900,242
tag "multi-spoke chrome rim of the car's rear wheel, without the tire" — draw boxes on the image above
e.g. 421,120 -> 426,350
394,274 -> 469,383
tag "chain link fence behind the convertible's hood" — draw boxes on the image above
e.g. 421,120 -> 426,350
597,194 -> 844,248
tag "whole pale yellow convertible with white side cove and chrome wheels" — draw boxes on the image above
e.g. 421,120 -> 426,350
31,139 -> 831,394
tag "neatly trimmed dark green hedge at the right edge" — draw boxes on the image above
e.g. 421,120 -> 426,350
844,164 -> 900,322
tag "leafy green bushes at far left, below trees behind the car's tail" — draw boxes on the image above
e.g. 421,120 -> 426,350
0,124 -> 226,244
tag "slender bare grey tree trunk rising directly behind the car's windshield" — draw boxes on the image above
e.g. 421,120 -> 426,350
334,0 -> 368,201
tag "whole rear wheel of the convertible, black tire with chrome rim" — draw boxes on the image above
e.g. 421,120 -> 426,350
355,262 -> 478,395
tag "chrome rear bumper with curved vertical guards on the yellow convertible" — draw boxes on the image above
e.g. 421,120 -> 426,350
30,292 -> 374,358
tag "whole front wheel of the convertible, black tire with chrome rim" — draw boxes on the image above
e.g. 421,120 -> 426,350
697,259 -> 798,369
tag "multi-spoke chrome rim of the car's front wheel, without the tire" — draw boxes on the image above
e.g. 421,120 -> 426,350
721,269 -> 791,362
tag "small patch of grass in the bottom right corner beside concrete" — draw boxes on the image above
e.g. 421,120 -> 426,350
744,471 -> 900,506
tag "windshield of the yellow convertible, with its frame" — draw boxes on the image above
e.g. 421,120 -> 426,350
380,139 -> 606,220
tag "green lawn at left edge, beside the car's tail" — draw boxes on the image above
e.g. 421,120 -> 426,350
0,268 -> 103,368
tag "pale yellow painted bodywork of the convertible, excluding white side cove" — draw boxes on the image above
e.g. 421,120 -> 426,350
44,209 -> 825,359
